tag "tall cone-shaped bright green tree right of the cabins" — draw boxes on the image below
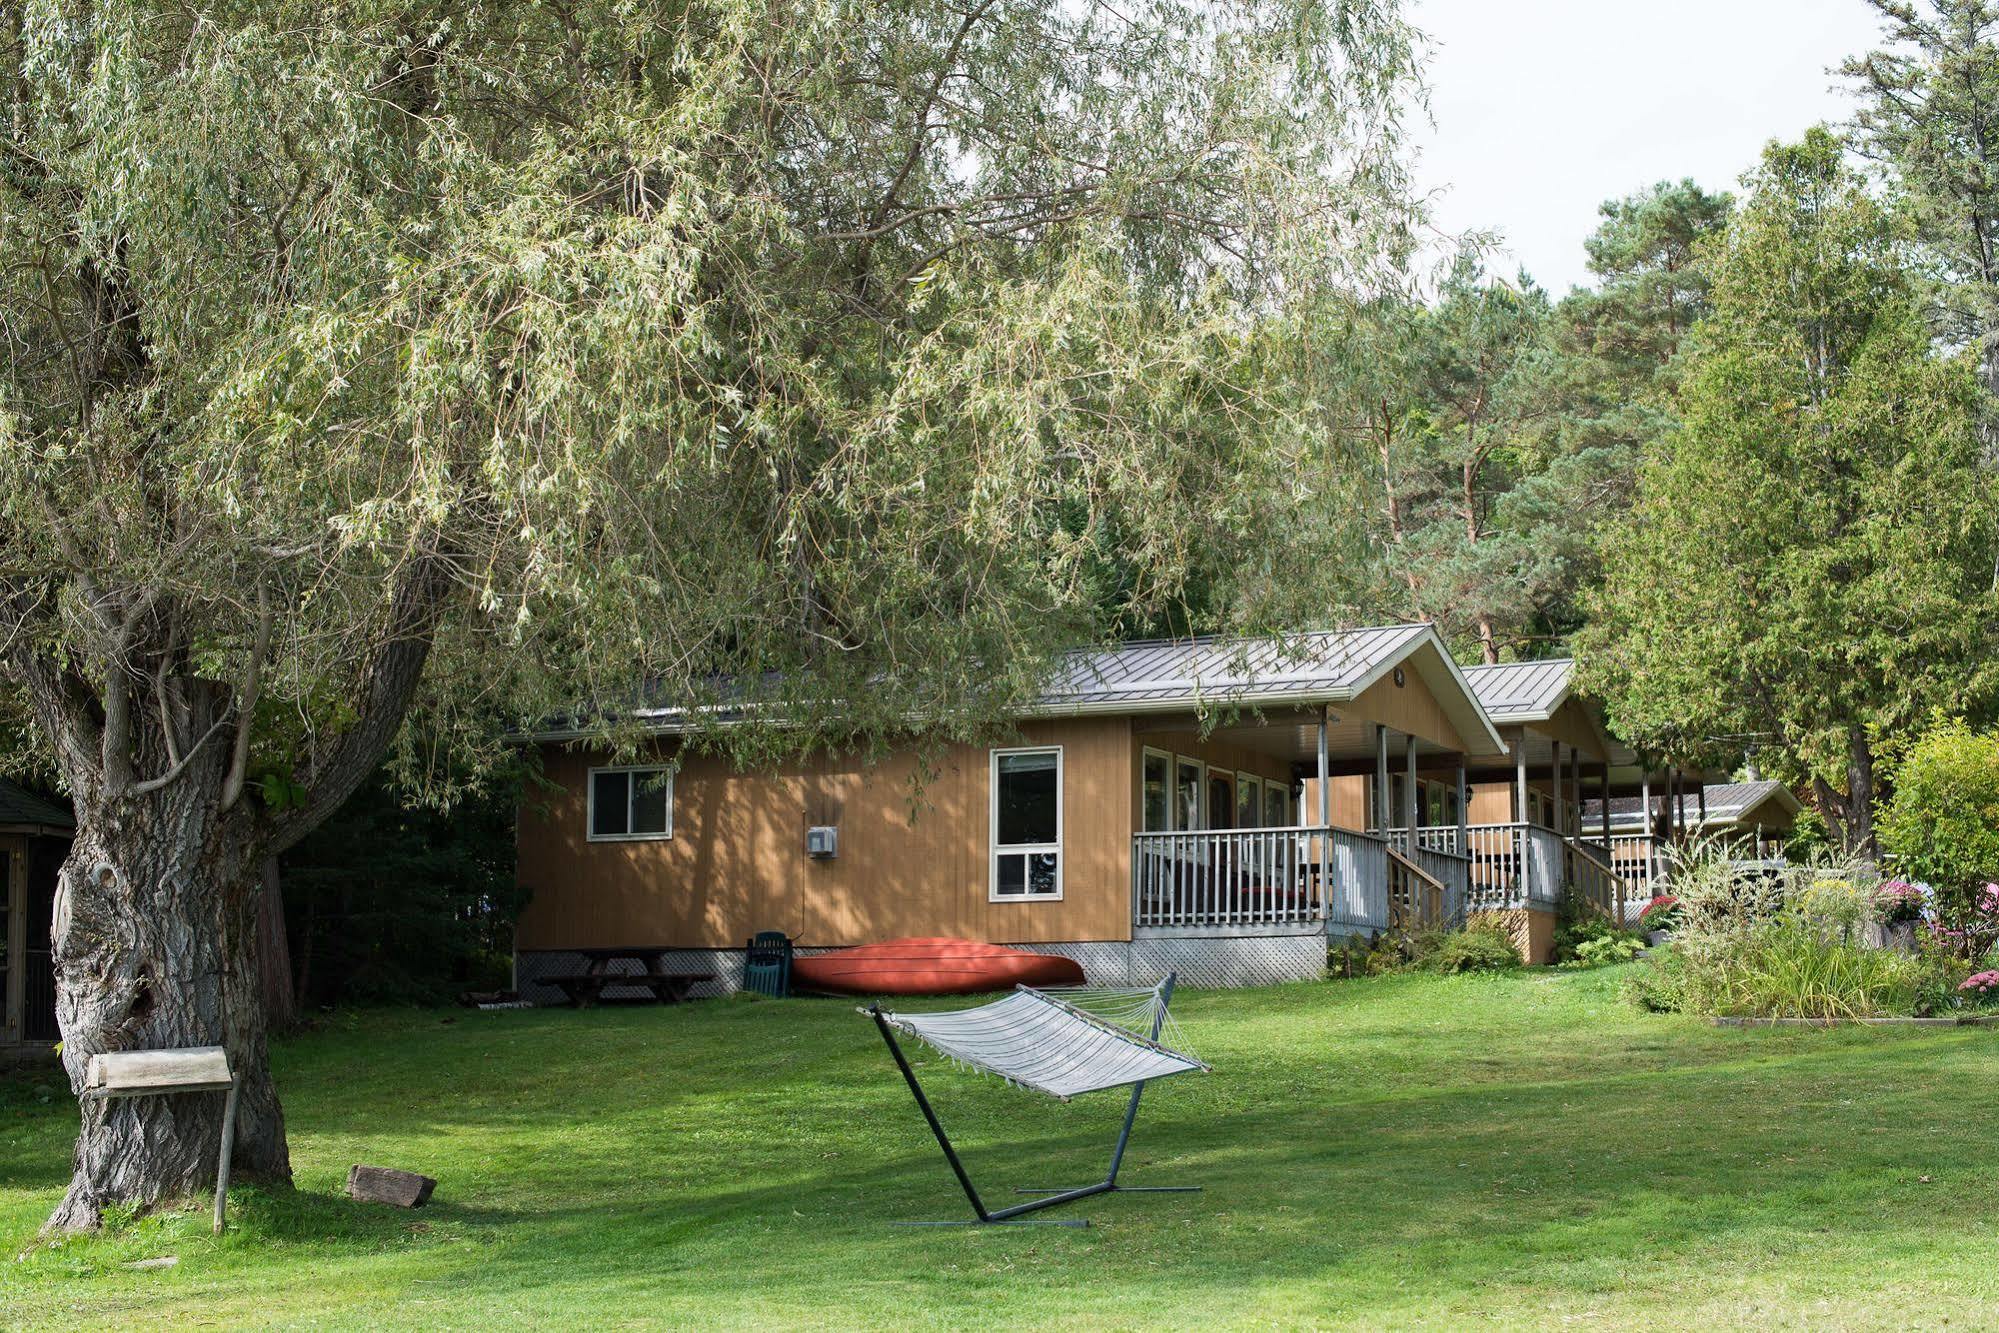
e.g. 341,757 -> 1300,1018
1579,130 -> 1999,845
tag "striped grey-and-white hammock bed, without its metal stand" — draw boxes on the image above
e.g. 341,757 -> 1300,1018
882,985 -> 1207,1101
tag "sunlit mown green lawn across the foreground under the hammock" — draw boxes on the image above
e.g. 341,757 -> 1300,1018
0,969 -> 1999,1329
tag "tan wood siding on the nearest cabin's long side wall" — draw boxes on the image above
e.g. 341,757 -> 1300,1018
518,717 -> 1137,949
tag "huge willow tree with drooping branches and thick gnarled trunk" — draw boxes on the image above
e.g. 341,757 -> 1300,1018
0,0 -> 1413,1227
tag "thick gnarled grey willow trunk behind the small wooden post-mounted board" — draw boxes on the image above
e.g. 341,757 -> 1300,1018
48,783 -> 292,1229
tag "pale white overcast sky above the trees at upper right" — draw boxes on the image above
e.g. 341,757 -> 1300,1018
1413,0 -> 1879,296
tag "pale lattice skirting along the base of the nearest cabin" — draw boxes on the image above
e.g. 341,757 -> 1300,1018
514,931 -> 1325,1005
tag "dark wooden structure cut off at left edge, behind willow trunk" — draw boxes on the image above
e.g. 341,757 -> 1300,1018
0,777 -> 76,1057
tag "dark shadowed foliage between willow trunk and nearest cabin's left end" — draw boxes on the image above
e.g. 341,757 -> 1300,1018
280,775 -> 526,1007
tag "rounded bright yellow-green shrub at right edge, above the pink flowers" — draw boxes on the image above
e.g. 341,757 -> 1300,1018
1877,719 -> 1999,961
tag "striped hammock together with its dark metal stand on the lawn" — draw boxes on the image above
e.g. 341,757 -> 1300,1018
864,973 -> 1207,1227
